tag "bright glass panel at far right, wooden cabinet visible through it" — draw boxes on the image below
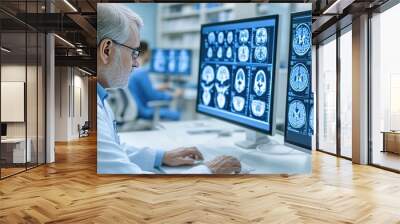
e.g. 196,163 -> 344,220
370,4 -> 400,171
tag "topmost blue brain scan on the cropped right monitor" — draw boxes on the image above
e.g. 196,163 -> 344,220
293,23 -> 311,56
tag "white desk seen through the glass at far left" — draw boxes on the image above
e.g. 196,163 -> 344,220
1,138 -> 32,163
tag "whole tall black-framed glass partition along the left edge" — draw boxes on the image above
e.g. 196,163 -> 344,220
0,1 -> 46,179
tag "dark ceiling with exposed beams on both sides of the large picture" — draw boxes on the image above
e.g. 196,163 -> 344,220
0,0 -> 394,73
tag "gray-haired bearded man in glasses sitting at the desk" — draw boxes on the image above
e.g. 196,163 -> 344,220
97,3 -> 241,174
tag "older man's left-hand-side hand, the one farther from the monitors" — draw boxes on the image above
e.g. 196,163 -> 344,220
163,147 -> 204,166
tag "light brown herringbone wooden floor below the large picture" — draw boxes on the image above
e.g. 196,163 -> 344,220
0,134 -> 400,224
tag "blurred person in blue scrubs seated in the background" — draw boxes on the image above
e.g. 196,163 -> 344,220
128,41 -> 180,121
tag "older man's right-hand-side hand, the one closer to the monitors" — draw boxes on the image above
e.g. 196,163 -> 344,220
205,156 -> 241,174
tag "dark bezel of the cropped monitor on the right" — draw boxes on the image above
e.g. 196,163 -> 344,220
284,10 -> 312,151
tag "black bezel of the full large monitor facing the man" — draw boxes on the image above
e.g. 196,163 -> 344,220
196,15 -> 279,135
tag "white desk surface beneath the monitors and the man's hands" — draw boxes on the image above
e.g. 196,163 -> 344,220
120,119 -> 311,174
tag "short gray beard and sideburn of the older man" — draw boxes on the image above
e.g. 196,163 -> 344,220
103,48 -> 130,88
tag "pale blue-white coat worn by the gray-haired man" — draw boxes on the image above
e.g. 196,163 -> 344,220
97,92 -> 210,174
